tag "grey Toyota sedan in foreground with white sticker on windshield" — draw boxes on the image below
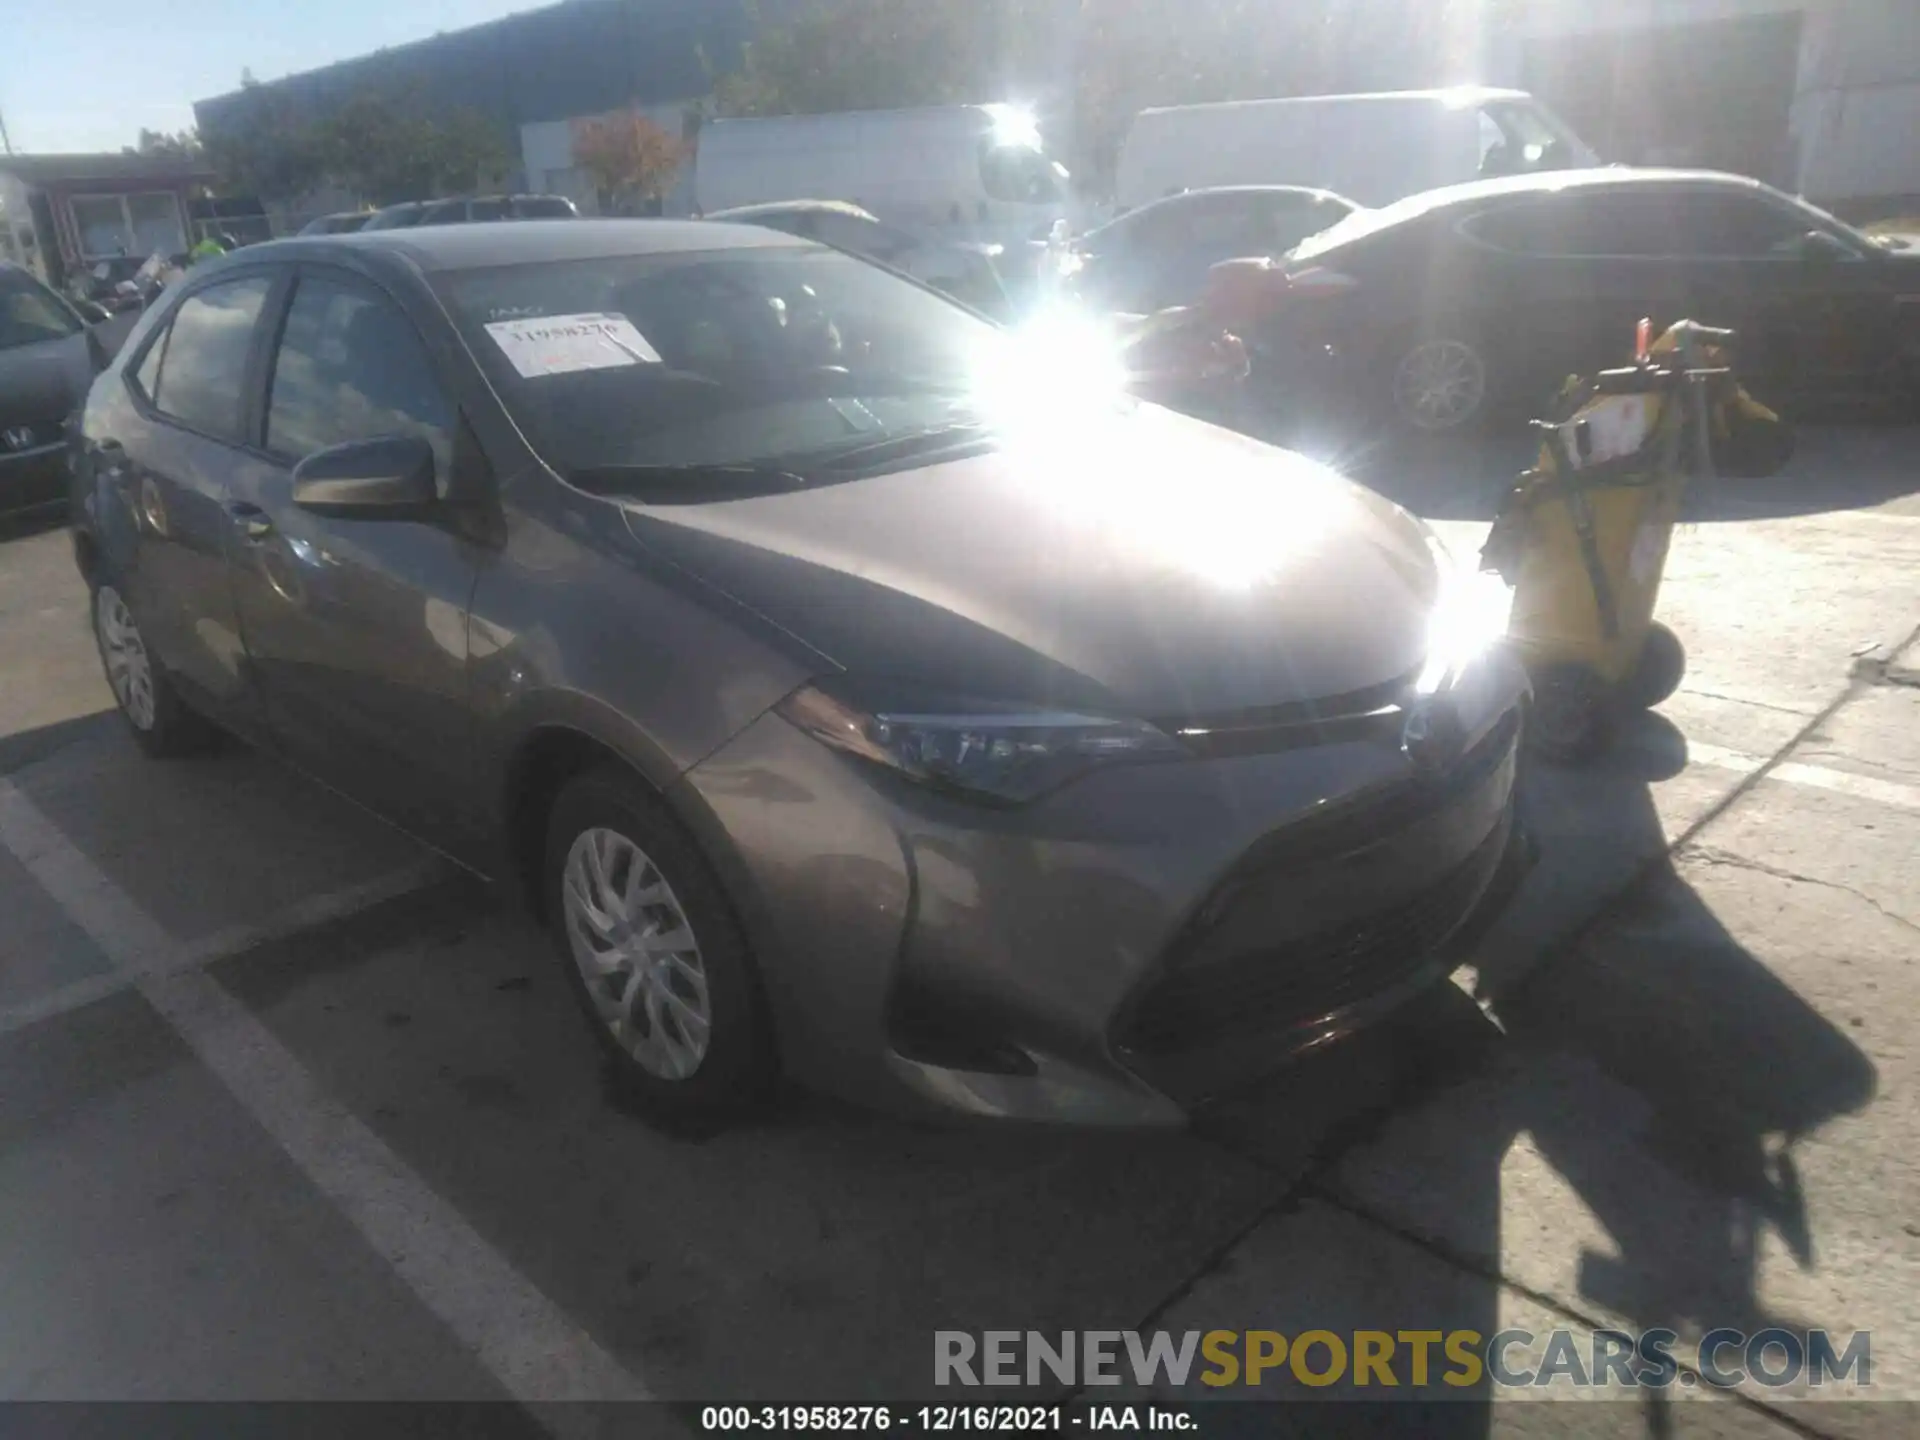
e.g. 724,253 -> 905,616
73,221 -> 1524,1125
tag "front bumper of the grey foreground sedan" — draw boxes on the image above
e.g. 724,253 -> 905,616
682,657 -> 1526,1127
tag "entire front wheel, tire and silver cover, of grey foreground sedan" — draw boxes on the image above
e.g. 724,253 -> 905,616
541,768 -> 774,1117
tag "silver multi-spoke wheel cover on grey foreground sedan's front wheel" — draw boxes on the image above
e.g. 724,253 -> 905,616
561,828 -> 712,1081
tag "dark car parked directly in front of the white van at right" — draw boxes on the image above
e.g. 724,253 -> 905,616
1064,184 -> 1356,315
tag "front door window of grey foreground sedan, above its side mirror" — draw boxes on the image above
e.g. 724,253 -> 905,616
267,278 -> 455,474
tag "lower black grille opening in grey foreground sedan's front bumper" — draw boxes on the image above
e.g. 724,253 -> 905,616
1116,816 -> 1511,1056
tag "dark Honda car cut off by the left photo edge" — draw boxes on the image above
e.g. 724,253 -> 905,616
0,261 -> 104,515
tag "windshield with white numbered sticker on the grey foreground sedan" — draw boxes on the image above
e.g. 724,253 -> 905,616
442,246 -> 1052,476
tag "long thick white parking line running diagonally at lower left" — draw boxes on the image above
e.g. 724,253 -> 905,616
0,780 -> 647,1413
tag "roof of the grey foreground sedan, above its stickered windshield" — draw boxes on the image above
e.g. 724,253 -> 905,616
196,219 -> 812,273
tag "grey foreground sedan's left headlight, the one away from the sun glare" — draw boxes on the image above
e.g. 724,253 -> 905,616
776,685 -> 1187,804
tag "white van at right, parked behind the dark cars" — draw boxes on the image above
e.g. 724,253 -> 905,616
1116,88 -> 1599,209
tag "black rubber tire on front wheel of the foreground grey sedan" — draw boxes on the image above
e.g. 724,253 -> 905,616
541,768 -> 776,1119
